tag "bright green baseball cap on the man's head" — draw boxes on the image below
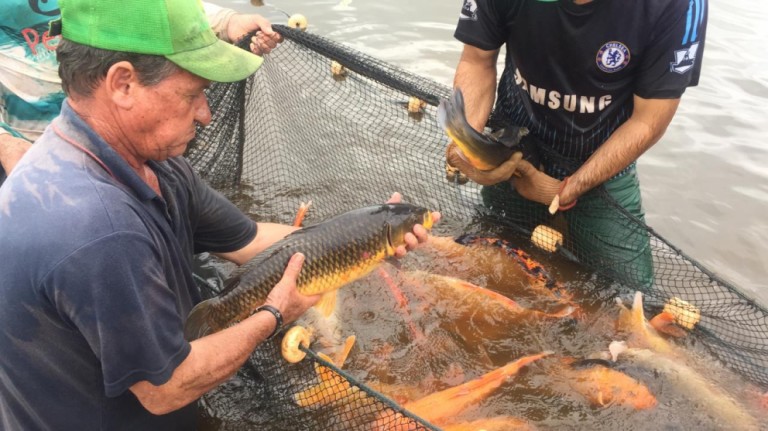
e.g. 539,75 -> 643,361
51,0 -> 263,82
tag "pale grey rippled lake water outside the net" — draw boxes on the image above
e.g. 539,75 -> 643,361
214,0 -> 768,305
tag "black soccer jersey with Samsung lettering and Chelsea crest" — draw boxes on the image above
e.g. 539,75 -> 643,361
455,0 -> 707,176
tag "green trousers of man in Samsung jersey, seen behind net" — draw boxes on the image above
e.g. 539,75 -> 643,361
482,168 -> 653,289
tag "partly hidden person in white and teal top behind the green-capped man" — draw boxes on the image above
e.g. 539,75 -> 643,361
0,0 -> 282,184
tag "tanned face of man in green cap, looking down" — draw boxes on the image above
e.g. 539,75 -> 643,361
132,70 -> 211,160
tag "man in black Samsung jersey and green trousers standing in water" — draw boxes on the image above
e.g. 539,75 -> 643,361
446,0 -> 708,286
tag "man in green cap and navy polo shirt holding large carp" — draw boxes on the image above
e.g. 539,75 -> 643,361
0,0 -> 438,431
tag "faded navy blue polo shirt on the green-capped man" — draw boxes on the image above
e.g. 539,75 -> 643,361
0,102 -> 256,431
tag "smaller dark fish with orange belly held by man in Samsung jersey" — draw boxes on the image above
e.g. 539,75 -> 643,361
437,88 -> 535,171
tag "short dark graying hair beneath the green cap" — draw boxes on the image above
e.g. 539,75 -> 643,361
56,39 -> 181,97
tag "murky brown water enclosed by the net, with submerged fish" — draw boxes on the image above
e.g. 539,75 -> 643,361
200,238 -> 768,431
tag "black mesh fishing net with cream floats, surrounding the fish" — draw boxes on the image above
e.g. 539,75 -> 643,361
187,25 -> 768,430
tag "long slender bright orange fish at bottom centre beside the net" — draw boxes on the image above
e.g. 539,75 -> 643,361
373,352 -> 552,431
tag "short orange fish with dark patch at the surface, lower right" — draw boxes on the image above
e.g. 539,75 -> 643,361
551,359 -> 657,410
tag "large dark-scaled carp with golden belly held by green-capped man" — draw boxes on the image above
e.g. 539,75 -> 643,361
184,204 -> 432,341
